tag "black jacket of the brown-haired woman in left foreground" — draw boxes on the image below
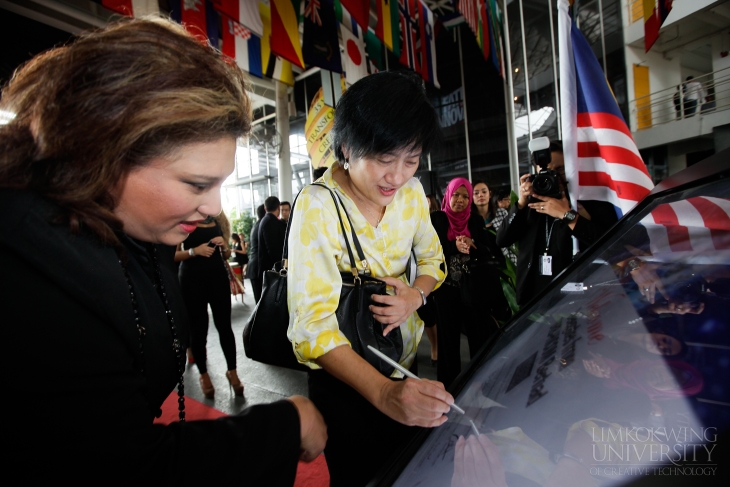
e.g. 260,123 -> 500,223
0,190 -> 300,485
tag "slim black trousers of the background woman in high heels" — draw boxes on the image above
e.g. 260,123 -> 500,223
180,273 -> 236,374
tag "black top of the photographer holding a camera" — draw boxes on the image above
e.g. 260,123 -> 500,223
497,201 -> 618,305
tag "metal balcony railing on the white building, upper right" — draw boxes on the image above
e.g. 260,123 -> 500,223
629,68 -> 730,130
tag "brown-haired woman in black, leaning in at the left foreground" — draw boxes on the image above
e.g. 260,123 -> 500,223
0,18 -> 327,486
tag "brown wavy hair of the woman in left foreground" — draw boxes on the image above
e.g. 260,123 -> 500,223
0,18 -> 251,244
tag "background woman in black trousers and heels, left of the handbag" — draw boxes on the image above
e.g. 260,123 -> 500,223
175,213 -> 243,399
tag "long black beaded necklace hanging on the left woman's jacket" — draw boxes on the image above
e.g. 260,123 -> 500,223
119,247 -> 185,423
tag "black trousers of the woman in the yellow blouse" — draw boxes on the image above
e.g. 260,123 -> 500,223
308,370 -> 421,487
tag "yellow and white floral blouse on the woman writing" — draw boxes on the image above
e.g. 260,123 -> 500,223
287,165 -> 445,377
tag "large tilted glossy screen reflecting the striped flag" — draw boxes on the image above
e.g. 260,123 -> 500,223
394,180 -> 730,487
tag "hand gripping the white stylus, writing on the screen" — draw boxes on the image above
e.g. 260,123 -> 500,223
377,379 -> 454,428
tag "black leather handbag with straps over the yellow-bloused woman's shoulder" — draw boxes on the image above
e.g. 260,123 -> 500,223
243,183 -> 403,377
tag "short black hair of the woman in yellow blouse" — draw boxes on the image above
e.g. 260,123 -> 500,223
332,71 -> 441,163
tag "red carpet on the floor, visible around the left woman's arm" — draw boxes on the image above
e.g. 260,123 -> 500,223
155,392 -> 330,487
